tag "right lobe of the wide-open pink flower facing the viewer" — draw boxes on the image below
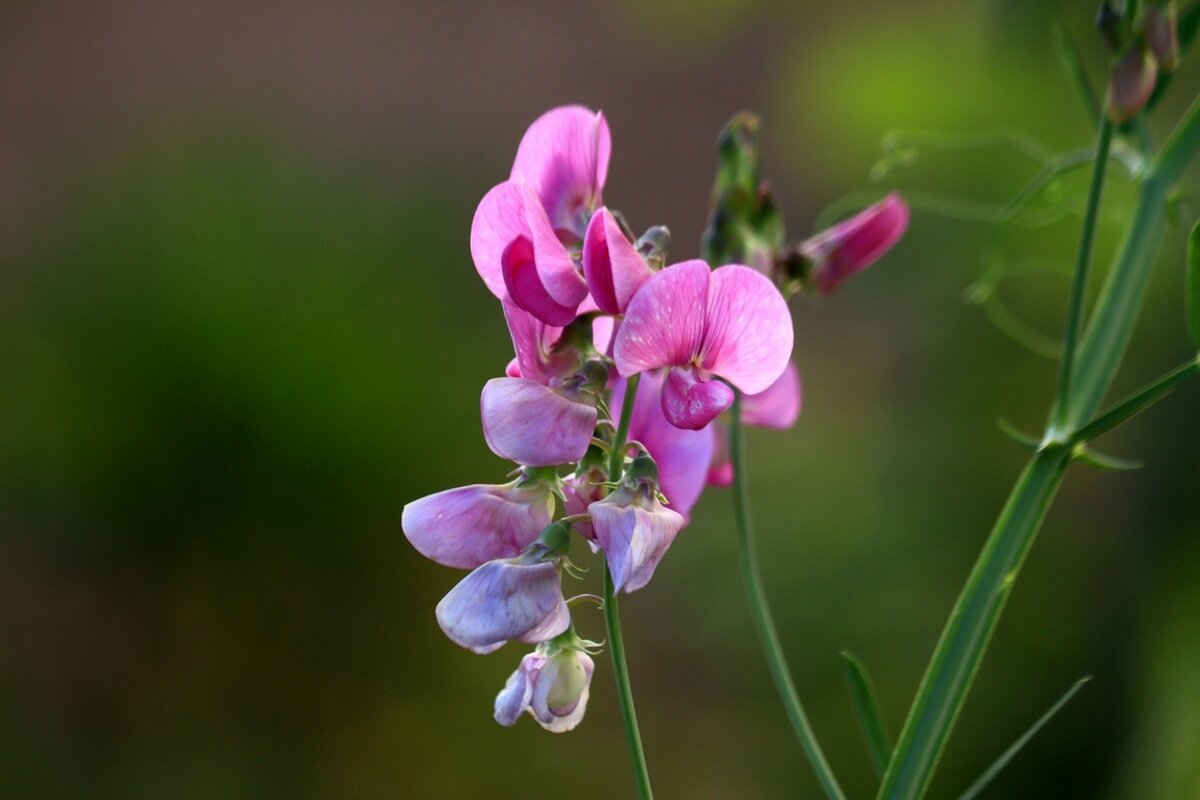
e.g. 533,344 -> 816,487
700,264 -> 792,395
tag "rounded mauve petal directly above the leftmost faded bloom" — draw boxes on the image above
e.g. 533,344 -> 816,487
480,378 -> 596,467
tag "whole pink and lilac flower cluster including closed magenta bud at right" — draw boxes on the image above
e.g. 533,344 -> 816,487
402,106 -> 907,732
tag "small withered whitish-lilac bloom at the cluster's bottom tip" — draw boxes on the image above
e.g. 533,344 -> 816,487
494,643 -> 595,733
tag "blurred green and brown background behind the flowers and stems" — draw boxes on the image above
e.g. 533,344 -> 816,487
0,0 -> 1200,799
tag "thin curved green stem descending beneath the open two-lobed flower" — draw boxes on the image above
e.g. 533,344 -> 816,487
730,392 -> 846,800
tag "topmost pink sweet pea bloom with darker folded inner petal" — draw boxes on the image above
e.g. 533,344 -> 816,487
470,106 -> 612,325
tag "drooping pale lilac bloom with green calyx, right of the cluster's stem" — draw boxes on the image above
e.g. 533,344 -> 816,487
588,456 -> 684,593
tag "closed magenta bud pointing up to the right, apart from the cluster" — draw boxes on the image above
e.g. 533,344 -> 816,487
800,193 -> 908,295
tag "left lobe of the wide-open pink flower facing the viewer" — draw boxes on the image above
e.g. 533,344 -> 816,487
612,260 -> 710,378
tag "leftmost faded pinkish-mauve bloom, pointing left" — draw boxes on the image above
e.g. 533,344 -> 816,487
400,480 -> 554,570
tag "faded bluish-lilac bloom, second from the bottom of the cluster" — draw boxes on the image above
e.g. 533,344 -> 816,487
437,552 -> 571,654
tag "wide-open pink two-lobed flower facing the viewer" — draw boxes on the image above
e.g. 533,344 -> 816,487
613,260 -> 792,429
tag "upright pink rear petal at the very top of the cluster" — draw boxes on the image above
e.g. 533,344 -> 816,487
511,106 -> 612,235
